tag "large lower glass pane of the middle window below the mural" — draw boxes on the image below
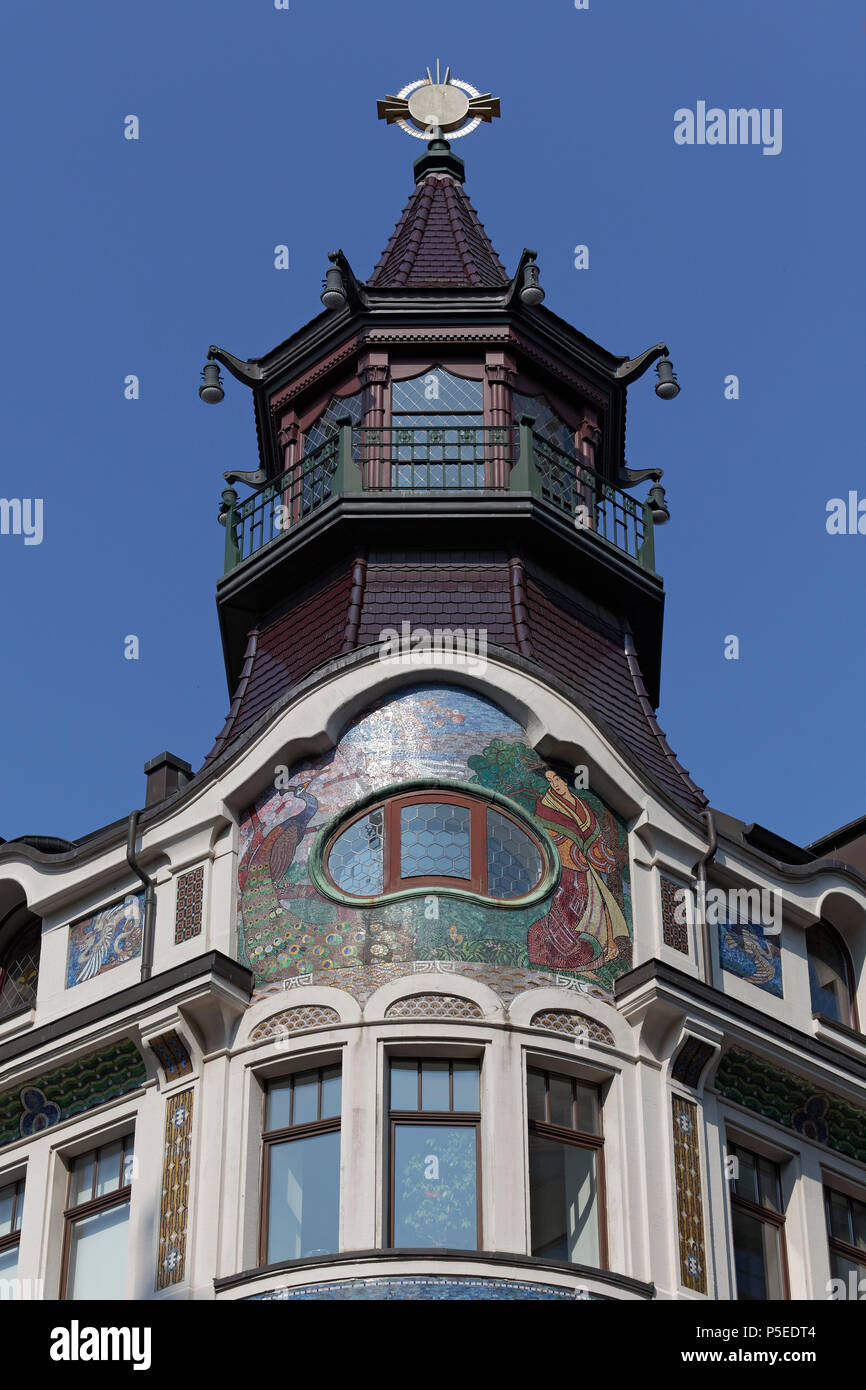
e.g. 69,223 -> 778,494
393,1125 -> 478,1250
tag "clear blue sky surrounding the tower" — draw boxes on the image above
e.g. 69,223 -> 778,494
0,0 -> 866,841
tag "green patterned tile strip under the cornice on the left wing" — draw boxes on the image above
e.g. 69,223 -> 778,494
0,1038 -> 147,1147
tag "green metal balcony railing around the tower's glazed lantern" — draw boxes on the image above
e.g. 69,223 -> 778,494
220,417 -> 655,574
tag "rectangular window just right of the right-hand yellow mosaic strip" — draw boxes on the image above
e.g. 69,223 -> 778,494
728,1144 -> 788,1302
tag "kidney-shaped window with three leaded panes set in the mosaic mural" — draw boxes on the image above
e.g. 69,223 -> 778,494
324,788 -> 548,902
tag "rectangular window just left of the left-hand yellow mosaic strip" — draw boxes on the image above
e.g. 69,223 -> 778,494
60,1134 -> 132,1300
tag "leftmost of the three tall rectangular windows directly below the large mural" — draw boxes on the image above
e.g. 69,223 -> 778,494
261,1066 -> 342,1265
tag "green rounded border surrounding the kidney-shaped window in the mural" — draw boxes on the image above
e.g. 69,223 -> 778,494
309,777 -> 562,912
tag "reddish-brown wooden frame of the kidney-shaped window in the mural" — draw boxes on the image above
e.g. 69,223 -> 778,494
322,787 -> 548,904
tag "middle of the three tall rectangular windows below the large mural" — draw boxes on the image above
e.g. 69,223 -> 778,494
389,1058 -> 481,1250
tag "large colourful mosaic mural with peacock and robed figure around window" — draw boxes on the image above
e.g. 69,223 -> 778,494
238,685 -> 632,998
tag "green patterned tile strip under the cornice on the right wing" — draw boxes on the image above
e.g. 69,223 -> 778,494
716,1049 -> 866,1163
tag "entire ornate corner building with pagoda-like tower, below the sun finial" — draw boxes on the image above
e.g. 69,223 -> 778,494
0,108 -> 866,1301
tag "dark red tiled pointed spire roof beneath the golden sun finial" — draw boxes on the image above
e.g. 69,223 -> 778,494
367,174 -> 509,289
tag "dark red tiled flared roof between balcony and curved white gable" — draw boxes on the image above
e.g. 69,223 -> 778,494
209,552 -> 706,812
